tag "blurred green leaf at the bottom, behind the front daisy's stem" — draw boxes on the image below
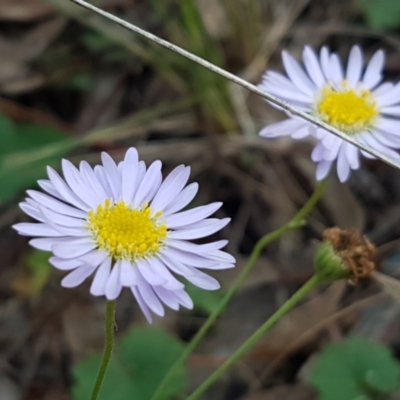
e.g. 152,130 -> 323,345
72,327 -> 187,400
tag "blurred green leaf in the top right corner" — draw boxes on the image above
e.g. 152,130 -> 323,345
357,0 -> 400,29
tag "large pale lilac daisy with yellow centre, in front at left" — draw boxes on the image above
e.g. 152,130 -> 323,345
14,148 -> 235,322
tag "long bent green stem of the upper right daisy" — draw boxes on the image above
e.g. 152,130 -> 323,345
151,180 -> 326,400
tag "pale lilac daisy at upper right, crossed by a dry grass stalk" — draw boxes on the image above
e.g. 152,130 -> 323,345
259,46 -> 400,182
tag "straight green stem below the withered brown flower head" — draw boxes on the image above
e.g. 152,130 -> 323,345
186,275 -> 321,400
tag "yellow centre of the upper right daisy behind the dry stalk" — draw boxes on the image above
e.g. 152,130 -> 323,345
315,83 -> 378,134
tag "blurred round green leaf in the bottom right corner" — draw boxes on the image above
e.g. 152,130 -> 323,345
311,337 -> 400,400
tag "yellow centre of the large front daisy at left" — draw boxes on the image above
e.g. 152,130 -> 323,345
88,199 -> 167,261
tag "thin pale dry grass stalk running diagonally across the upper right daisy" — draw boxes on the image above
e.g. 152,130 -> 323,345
71,0 -> 400,169
